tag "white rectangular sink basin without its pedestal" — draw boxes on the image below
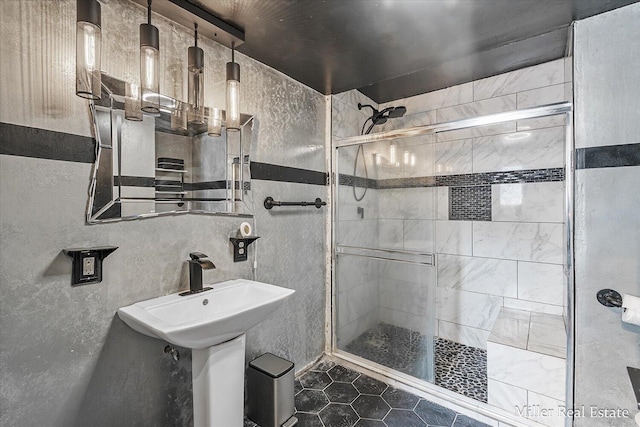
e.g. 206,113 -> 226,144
118,279 -> 295,349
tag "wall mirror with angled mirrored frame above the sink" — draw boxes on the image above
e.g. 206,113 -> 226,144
87,74 -> 253,223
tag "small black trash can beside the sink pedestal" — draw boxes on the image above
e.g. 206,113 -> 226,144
247,353 -> 297,427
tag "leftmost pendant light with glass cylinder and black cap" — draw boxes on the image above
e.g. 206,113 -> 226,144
76,0 -> 102,99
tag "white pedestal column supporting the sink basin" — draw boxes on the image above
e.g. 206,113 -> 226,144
191,334 -> 246,427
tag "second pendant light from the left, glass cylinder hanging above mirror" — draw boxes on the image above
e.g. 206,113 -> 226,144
140,0 -> 160,114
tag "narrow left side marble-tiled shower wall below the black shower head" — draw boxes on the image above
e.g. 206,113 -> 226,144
331,91 -> 382,348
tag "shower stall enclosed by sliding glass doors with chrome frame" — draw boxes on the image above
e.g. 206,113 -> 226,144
332,103 -> 573,426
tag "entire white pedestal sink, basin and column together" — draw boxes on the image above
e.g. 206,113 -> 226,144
118,279 -> 295,427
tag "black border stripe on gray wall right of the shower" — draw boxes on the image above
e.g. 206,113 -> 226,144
576,143 -> 640,169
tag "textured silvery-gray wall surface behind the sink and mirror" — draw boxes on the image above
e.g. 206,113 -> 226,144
0,0 -> 327,426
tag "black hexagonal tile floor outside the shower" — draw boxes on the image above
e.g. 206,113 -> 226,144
245,362 -> 487,427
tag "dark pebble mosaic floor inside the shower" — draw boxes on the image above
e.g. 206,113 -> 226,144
345,323 -> 487,403
